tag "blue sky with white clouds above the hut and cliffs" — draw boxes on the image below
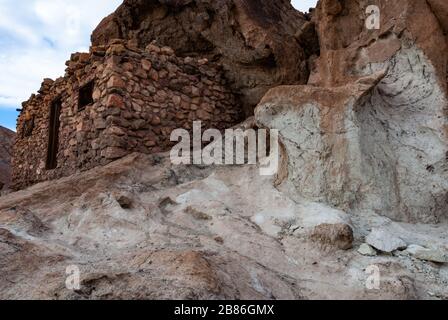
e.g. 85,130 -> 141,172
0,0 -> 316,129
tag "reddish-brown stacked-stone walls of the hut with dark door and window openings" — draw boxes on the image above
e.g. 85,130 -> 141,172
12,40 -> 242,189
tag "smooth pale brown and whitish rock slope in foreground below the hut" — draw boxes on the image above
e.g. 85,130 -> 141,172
0,154 -> 448,299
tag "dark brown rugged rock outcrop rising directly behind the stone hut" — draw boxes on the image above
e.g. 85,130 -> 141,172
92,0 -> 318,113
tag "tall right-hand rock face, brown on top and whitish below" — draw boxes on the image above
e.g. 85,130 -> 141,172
256,0 -> 448,223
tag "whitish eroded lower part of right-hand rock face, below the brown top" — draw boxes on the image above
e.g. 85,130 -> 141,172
255,47 -> 448,223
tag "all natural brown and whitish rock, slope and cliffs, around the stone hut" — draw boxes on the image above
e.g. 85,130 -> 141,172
0,0 -> 448,299
